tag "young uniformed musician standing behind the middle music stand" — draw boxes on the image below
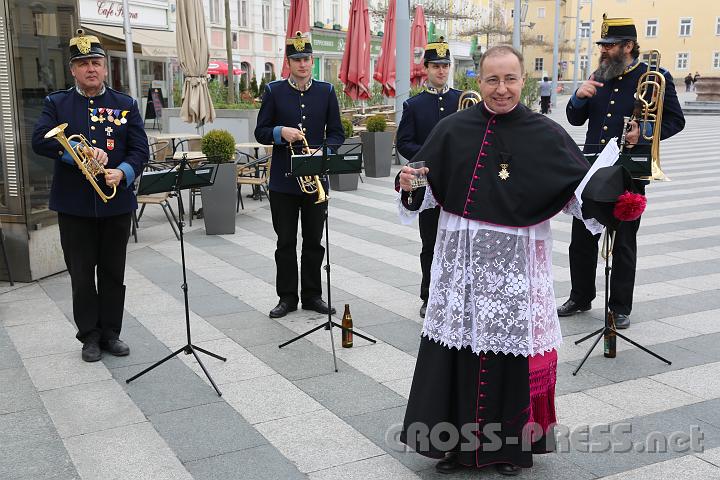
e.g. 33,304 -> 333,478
255,32 -> 345,318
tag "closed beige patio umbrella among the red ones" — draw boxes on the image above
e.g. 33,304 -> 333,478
175,0 -> 215,127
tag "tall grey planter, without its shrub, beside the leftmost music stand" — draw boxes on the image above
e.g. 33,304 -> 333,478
200,163 -> 237,235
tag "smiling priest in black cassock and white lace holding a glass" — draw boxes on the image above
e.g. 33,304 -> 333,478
400,46 -> 602,475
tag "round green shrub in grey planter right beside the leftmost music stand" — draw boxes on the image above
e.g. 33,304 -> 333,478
200,130 -> 237,235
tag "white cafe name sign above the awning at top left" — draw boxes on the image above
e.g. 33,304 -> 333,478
80,0 -> 168,29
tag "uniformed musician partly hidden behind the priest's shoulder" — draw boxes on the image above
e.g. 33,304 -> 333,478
396,37 -> 462,318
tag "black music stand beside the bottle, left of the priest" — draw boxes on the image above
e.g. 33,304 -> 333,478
278,143 -> 376,372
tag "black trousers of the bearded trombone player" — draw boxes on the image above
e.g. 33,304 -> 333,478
570,209 -> 640,315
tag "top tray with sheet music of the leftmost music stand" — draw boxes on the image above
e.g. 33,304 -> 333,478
137,158 -> 217,195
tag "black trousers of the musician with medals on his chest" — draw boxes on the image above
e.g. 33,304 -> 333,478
58,213 -> 132,343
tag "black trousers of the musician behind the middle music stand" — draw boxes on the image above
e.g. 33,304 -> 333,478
270,191 -> 327,305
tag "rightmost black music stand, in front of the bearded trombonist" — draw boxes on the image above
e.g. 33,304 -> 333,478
573,163 -> 672,376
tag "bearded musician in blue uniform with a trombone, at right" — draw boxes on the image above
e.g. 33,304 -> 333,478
558,16 -> 685,328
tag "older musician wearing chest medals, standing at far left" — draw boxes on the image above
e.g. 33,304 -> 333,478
32,30 -> 149,362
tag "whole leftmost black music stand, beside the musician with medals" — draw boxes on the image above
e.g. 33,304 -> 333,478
125,154 -> 227,396
